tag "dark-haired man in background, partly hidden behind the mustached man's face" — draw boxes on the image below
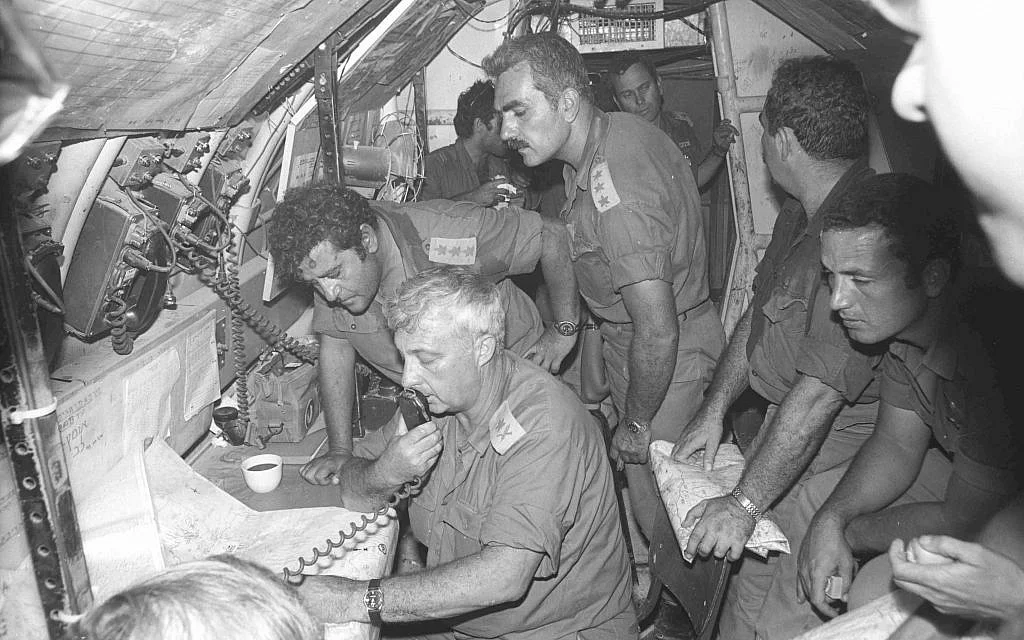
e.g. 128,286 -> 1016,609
419,80 -> 509,207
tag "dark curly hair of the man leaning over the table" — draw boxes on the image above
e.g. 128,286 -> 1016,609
267,182 -> 378,278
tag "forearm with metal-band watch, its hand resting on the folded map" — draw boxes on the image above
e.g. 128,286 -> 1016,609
739,376 -> 843,509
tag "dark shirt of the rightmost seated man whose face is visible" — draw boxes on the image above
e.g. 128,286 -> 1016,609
881,316 -> 1020,495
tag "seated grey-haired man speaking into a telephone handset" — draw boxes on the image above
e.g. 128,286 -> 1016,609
302,267 -> 637,640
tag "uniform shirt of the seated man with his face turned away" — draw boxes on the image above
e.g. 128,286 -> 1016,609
746,160 -> 881,429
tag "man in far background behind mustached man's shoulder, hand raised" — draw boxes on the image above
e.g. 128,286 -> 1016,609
608,51 -> 739,189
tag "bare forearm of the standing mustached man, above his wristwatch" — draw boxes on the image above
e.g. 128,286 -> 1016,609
621,316 -> 679,422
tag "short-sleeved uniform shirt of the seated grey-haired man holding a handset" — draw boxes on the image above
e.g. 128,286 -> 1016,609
409,351 -> 636,640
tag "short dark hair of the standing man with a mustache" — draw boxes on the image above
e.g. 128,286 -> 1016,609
483,32 -> 594,106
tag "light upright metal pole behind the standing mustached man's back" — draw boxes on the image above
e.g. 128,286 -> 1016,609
708,2 -> 757,336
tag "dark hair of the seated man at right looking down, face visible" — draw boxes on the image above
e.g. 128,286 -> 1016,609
823,173 -> 961,287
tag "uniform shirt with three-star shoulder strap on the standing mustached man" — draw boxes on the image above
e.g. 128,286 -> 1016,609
562,110 -> 709,323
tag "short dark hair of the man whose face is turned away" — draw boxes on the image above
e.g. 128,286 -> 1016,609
762,55 -> 870,160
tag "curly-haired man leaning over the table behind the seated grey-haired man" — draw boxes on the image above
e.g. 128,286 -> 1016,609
269,183 -> 580,488
